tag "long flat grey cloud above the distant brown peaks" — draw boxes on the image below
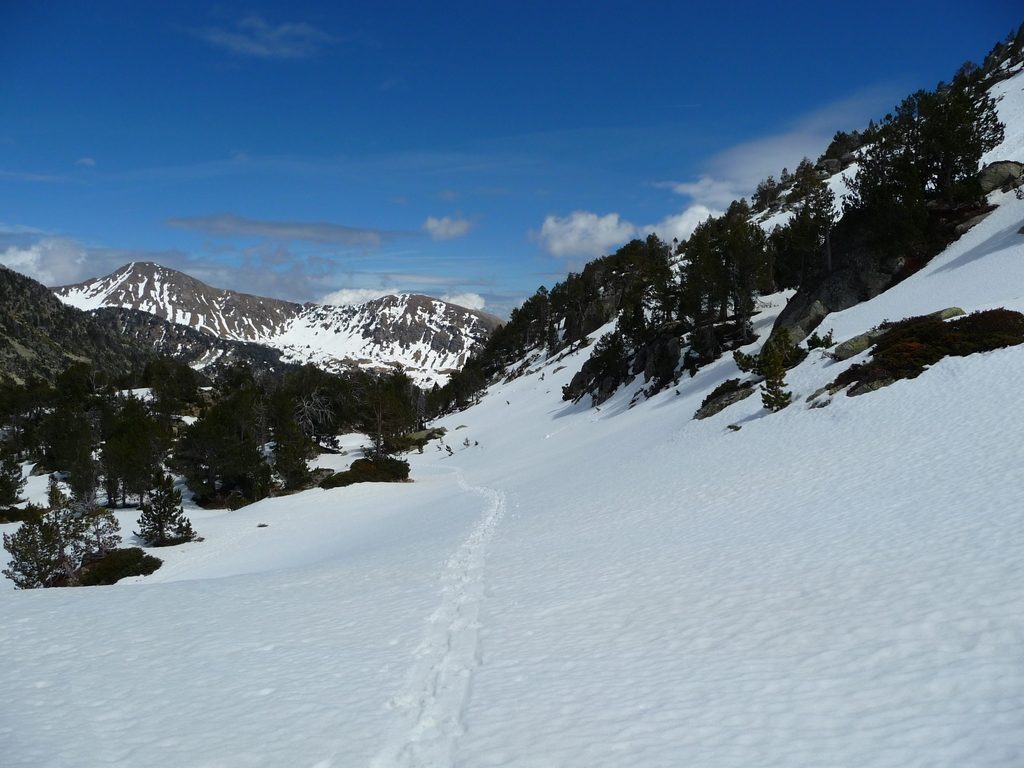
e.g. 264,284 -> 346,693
164,213 -> 403,247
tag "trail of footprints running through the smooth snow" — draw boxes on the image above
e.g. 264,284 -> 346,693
371,469 -> 505,768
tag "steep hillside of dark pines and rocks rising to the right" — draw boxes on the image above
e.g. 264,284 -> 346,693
430,28 -> 1024,413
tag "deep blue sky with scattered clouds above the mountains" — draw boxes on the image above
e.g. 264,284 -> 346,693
0,0 -> 1024,314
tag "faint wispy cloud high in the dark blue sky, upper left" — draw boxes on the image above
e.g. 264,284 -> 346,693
195,16 -> 334,59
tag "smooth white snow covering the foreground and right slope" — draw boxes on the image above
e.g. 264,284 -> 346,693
6,67 -> 1024,768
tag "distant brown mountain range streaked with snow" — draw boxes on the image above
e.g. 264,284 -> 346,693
53,262 -> 499,385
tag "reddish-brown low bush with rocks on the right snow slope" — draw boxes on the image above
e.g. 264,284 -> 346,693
829,308 -> 1024,395
